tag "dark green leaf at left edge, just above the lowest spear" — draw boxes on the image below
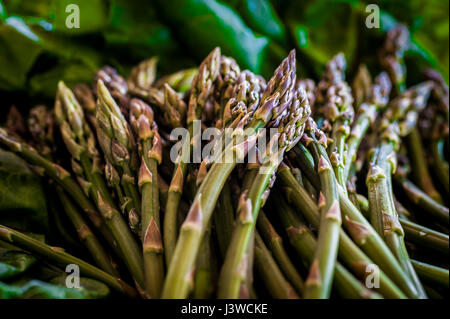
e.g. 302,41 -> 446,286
0,149 -> 48,233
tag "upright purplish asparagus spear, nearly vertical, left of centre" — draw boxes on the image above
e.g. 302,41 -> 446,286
130,99 -> 164,298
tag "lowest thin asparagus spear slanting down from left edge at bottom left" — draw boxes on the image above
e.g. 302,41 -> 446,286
0,225 -> 136,297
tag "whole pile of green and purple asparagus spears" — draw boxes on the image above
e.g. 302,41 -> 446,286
0,26 -> 449,299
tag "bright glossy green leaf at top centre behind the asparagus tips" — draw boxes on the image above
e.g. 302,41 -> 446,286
159,0 -> 285,76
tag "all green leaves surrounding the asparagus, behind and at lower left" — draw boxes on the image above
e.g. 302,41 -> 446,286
0,0 -> 449,298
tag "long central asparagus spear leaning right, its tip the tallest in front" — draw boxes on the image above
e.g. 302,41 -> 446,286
162,51 -> 295,298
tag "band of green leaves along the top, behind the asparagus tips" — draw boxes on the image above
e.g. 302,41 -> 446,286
0,0 -> 449,98
